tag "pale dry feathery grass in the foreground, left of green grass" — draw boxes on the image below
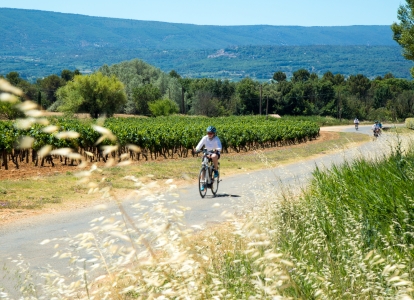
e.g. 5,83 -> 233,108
0,80 -> 291,299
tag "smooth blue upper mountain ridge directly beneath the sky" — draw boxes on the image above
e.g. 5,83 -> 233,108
0,8 -> 395,51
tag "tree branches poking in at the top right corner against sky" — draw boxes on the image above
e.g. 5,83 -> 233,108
391,0 -> 414,77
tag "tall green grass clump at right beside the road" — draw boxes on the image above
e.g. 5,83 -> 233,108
267,139 -> 414,299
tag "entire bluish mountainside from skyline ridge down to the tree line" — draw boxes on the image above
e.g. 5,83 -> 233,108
0,8 -> 413,81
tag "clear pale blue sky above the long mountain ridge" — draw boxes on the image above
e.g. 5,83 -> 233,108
0,0 -> 406,26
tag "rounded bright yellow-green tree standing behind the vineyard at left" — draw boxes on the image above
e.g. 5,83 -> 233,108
56,72 -> 126,118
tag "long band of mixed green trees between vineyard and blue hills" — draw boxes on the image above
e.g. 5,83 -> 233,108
0,59 -> 414,121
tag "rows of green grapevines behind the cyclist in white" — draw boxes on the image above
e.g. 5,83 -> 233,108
0,116 -> 319,169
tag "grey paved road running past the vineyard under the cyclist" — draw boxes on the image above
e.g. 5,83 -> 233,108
0,126 -> 406,285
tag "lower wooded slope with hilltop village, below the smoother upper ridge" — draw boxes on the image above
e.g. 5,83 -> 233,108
4,46 -> 413,81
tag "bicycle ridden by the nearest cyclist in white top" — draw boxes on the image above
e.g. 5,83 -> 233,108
198,149 -> 220,198
